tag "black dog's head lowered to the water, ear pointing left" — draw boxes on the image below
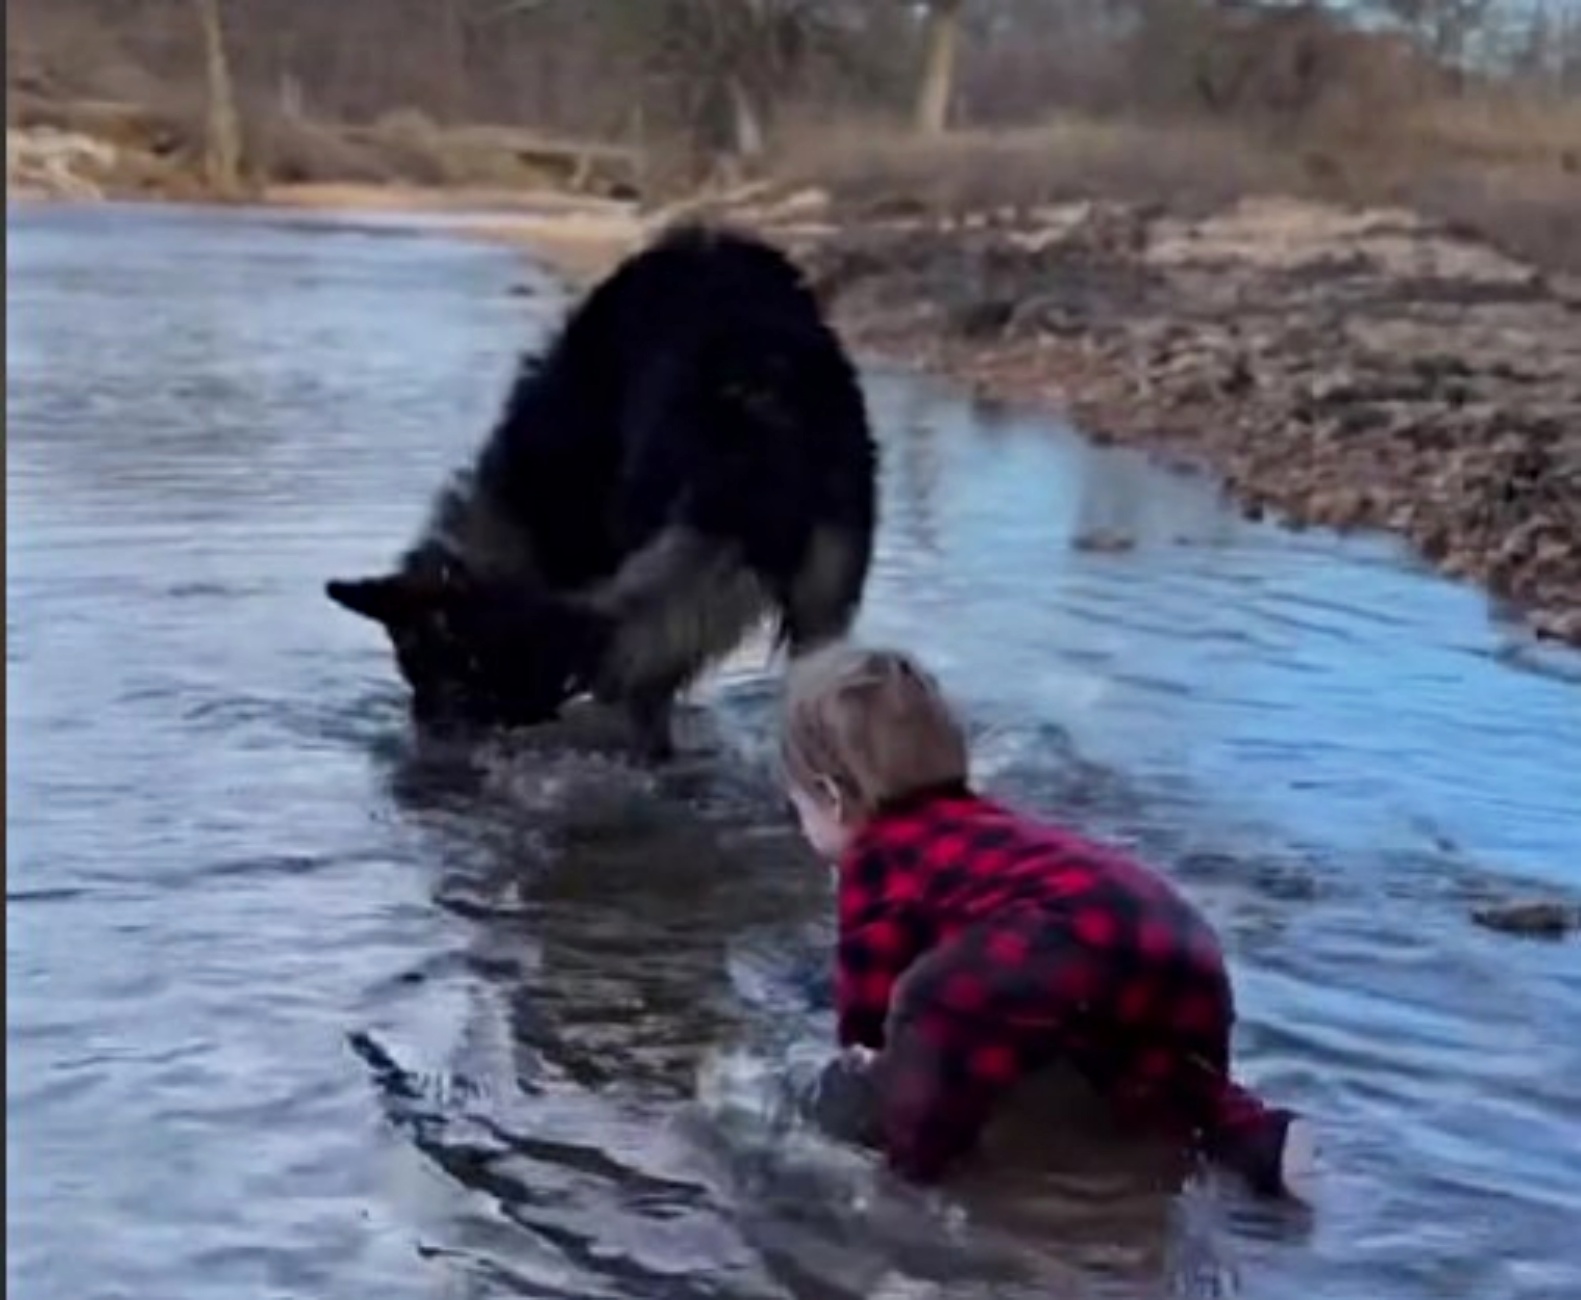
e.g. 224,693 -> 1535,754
324,563 -> 606,726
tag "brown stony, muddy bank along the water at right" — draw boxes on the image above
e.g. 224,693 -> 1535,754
792,199 -> 1581,644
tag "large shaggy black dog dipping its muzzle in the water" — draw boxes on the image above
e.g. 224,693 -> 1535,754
327,226 -> 877,758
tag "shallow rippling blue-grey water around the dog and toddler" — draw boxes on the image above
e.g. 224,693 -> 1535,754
6,209 -> 1581,1300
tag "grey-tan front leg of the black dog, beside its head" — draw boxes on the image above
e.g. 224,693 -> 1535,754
590,525 -> 768,758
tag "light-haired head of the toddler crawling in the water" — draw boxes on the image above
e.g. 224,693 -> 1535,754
779,645 -> 966,859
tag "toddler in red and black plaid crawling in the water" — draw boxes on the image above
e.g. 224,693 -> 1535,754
781,645 -> 1311,1194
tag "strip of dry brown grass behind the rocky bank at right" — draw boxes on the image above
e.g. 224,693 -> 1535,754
778,98 -> 1581,274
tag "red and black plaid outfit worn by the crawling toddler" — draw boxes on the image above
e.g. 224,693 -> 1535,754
835,786 -> 1290,1191
